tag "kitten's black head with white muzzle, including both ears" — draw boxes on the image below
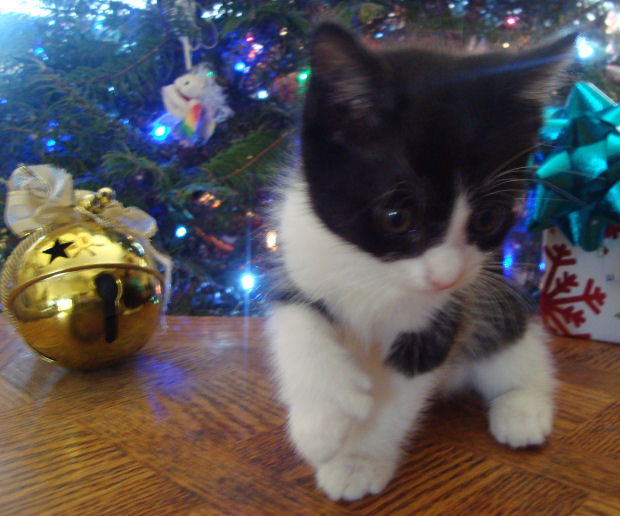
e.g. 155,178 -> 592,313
302,23 -> 574,291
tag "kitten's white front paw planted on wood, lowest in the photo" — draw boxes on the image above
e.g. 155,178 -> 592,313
316,455 -> 396,500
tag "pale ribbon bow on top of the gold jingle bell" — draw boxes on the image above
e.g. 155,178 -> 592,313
4,165 -> 157,238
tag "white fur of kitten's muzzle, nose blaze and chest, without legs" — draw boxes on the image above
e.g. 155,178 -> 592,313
278,182 -> 484,346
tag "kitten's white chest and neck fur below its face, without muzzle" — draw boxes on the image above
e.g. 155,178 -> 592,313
280,178 -> 449,351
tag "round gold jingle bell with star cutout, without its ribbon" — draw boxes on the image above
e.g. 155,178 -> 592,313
3,222 -> 165,370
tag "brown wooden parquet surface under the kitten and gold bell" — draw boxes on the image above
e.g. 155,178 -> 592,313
0,317 -> 620,516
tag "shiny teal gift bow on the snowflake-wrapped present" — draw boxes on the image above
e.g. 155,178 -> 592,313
529,82 -> 620,251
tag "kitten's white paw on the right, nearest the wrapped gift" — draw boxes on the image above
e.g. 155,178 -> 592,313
489,389 -> 553,448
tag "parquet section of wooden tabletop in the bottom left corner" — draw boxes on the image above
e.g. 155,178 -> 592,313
0,412 -> 199,515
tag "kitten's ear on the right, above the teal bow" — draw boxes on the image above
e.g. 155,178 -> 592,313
510,33 -> 577,106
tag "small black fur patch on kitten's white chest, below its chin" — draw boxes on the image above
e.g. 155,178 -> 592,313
385,303 -> 460,376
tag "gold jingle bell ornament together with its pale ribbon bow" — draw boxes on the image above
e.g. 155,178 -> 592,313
0,165 -> 172,370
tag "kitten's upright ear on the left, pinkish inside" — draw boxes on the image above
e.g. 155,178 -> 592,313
310,22 -> 384,118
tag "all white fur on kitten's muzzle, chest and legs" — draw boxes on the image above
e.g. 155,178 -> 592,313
269,182 -> 553,500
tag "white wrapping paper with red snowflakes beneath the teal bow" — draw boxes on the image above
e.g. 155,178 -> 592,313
540,226 -> 620,344
